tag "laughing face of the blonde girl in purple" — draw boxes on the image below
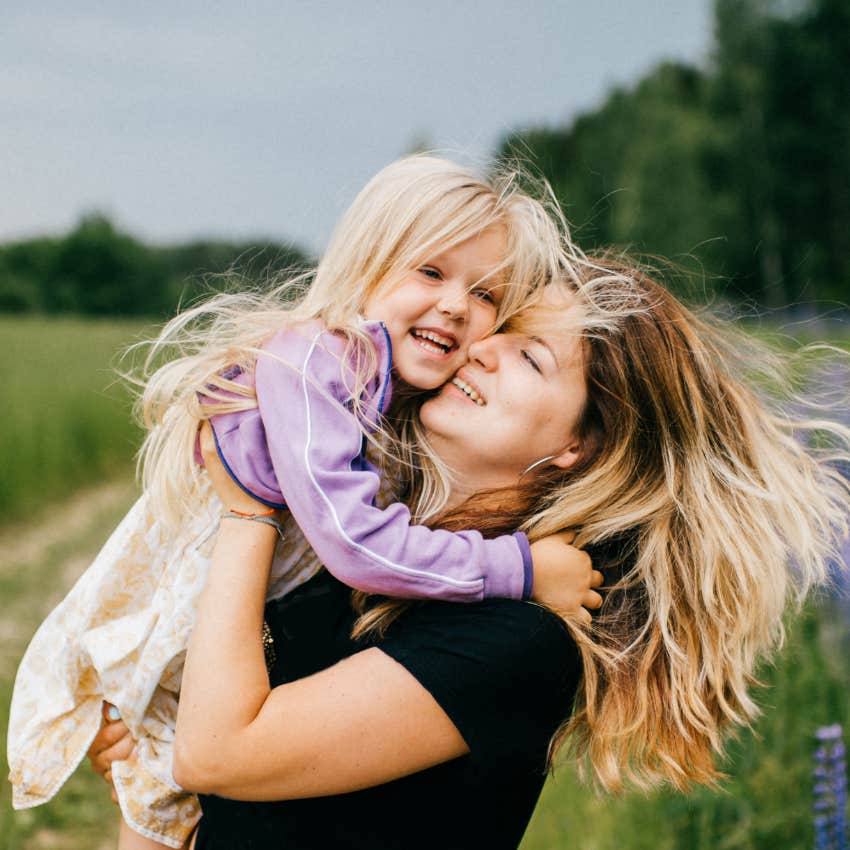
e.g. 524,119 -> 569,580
363,226 -> 507,390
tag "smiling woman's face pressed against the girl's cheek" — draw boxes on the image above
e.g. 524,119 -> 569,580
421,290 -> 587,496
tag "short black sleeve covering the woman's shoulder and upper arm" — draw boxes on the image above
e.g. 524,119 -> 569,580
376,600 -> 580,766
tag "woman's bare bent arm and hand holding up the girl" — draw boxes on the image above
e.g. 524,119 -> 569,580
174,424 -> 468,800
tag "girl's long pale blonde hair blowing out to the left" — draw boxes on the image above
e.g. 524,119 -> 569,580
134,155 -> 569,529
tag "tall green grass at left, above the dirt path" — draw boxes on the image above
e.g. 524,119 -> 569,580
0,316 -> 144,524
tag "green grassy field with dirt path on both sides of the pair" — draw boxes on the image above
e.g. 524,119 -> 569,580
0,318 -> 850,850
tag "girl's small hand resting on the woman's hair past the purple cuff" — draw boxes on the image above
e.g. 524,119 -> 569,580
531,532 -> 603,624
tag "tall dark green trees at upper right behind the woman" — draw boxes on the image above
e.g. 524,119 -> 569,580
499,0 -> 850,308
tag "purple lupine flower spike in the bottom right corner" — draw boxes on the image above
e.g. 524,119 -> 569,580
813,723 -> 847,850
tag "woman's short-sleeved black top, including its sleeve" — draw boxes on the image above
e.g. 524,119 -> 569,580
197,573 -> 580,850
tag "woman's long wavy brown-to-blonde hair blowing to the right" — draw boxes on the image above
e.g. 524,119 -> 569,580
356,254 -> 850,790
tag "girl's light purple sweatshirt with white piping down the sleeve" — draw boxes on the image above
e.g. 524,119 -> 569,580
200,322 -> 532,602
